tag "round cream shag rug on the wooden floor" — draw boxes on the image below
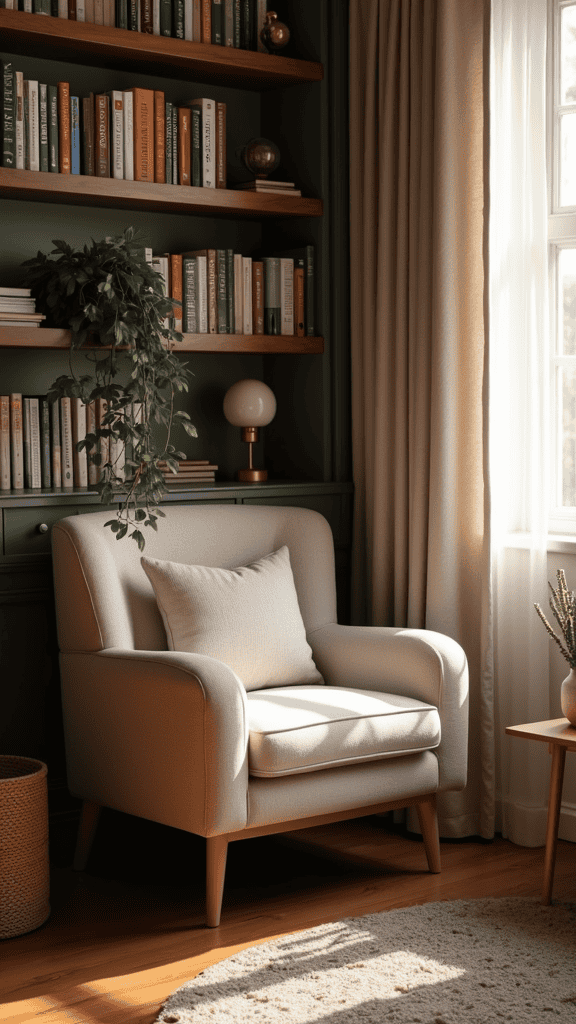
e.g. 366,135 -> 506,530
157,897 -> 576,1024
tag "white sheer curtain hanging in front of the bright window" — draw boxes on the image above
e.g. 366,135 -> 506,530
489,0 -> 551,846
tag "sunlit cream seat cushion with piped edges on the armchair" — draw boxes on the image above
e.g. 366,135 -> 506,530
242,685 -> 441,778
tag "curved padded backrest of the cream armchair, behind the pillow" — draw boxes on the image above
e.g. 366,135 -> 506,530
52,503 -> 336,651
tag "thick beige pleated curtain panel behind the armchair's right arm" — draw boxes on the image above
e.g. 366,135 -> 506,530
349,0 -> 494,837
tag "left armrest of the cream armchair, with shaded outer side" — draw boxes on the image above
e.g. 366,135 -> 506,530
60,648 -> 248,836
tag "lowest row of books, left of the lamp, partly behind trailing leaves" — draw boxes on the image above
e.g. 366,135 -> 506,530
0,393 -> 130,490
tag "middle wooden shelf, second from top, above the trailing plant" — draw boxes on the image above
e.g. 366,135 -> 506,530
0,167 -> 323,220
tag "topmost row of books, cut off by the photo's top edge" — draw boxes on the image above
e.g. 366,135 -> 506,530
0,0 -> 268,53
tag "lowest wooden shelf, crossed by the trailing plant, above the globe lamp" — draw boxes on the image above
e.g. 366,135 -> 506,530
0,327 -> 324,355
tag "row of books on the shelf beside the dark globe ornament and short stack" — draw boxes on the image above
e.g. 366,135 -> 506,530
1,60 -> 227,188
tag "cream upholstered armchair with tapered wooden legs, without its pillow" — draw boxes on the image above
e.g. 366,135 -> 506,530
52,504 -> 467,927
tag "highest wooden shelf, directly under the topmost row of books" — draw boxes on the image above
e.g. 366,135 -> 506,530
0,9 -> 324,89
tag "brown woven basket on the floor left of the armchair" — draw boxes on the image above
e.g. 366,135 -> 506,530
0,755 -> 50,939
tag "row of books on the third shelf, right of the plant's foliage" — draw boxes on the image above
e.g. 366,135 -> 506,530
147,245 -> 316,337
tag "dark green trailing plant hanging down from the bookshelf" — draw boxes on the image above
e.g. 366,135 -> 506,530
23,227 -> 197,551
